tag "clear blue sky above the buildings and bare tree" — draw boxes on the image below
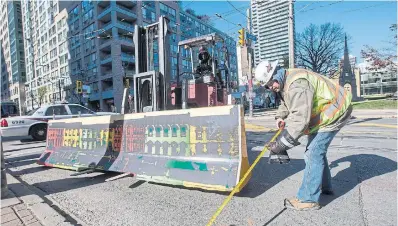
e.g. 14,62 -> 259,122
183,0 -> 397,63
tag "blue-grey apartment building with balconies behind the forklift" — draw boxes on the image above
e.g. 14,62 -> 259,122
62,1 -> 237,111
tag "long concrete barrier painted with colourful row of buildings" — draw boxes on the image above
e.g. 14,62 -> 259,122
38,105 -> 250,191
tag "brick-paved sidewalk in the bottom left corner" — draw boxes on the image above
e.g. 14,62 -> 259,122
1,173 -> 73,226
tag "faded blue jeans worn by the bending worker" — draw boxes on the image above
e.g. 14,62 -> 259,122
297,131 -> 338,203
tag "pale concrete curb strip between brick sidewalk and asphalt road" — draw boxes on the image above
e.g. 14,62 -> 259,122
7,172 -> 82,226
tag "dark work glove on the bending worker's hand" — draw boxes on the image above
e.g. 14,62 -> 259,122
268,131 -> 300,164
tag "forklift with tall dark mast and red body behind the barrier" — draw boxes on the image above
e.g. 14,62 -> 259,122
122,16 -> 230,113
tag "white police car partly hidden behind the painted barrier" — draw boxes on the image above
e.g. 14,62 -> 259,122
0,103 -> 118,140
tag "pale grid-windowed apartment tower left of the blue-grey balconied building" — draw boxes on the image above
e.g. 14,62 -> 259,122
22,1 -> 71,110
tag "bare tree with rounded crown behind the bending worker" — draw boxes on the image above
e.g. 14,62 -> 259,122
295,23 -> 345,74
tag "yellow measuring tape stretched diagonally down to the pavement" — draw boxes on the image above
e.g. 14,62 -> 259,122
207,129 -> 283,226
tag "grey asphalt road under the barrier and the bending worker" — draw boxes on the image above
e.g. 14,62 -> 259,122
3,118 -> 397,226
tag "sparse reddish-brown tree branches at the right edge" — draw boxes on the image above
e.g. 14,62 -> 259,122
361,24 -> 398,72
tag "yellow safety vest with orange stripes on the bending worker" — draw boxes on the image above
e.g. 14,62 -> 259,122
284,69 -> 352,134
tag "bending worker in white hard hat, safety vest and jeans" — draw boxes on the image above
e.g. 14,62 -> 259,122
255,61 -> 352,210
